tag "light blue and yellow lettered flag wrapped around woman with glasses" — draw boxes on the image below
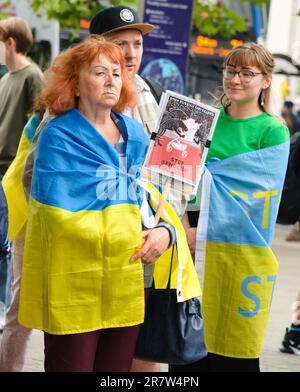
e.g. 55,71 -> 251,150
196,142 -> 289,358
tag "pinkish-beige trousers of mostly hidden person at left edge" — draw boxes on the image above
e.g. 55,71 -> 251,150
0,229 -> 31,372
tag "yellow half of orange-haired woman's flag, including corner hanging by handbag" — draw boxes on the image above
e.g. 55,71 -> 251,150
19,188 -> 201,334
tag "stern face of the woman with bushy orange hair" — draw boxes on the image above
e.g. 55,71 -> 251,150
76,55 -> 122,109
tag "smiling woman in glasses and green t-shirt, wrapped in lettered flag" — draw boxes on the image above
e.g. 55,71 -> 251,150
169,43 -> 289,372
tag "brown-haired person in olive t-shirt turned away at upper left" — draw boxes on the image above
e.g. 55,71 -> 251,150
0,17 -> 43,175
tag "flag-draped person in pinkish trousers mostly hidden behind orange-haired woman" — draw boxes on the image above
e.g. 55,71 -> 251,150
0,101 -> 45,372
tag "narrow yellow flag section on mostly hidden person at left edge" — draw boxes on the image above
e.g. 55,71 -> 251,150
2,132 -> 30,241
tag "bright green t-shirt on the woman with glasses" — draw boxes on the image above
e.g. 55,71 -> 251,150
189,109 -> 289,210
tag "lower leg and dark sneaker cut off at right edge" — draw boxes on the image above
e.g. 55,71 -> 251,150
279,291 -> 300,355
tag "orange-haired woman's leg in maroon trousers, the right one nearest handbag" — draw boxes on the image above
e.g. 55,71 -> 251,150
94,325 -> 140,372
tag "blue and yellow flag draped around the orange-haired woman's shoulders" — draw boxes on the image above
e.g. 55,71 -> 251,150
19,109 -> 202,334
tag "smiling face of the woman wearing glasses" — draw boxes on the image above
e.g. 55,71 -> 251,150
223,64 -> 272,107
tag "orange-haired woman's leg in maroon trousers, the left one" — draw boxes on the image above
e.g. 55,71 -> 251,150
44,330 -> 102,372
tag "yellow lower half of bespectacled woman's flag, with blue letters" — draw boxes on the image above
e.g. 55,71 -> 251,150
202,242 -> 278,358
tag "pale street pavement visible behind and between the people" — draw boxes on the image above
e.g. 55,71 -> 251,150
0,225 -> 300,372
